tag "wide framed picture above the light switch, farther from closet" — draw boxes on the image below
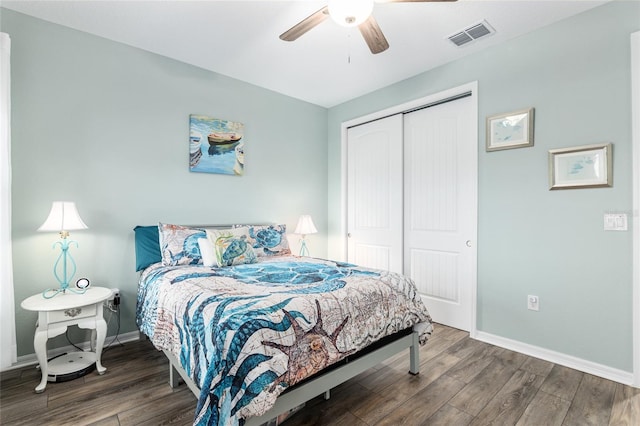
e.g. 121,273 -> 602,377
549,143 -> 613,189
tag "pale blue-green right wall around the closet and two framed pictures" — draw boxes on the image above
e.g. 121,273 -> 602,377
327,2 -> 640,371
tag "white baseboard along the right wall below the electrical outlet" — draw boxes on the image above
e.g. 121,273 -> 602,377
473,331 -> 634,386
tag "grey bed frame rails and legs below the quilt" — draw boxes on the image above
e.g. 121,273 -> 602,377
163,330 -> 420,426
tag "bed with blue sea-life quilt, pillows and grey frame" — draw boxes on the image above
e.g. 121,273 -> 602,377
135,223 -> 432,425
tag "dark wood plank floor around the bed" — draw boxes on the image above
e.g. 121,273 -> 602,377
0,325 -> 640,426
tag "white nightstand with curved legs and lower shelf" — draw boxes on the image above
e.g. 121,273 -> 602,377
20,287 -> 111,393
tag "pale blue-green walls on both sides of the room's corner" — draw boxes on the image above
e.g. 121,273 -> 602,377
0,2 -> 640,371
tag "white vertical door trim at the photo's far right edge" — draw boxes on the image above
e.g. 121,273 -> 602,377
631,31 -> 640,387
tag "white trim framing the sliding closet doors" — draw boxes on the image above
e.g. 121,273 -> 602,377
338,81 -> 478,338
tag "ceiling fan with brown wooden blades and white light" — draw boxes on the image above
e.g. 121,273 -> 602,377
280,0 -> 457,55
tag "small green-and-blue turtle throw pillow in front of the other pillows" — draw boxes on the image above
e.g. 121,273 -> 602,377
207,228 -> 258,267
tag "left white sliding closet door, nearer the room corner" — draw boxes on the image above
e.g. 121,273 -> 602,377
347,114 -> 403,273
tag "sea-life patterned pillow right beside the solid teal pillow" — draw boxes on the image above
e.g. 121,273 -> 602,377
158,223 -> 207,266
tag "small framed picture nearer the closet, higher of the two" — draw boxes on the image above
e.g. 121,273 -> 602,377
487,108 -> 533,151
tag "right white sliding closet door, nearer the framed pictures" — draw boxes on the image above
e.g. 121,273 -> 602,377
404,97 -> 478,330
